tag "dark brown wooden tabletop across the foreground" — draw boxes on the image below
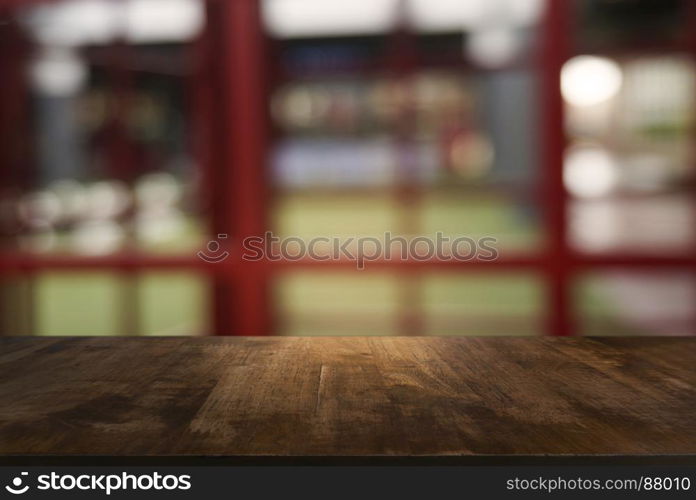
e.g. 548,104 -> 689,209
0,337 -> 696,463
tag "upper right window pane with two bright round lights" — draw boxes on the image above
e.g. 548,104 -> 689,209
563,55 -> 696,254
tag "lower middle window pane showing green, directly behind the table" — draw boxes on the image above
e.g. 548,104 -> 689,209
277,272 -> 543,335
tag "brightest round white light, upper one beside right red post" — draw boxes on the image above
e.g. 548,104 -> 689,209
561,56 -> 623,106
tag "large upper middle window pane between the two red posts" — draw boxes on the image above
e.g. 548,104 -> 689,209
264,15 -> 541,258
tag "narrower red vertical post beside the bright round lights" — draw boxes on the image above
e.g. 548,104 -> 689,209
540,0 -> 575,335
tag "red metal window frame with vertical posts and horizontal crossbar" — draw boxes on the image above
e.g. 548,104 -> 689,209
0,0 -> 696,335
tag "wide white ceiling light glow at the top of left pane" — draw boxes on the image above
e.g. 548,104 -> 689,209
27,0 -> 203,46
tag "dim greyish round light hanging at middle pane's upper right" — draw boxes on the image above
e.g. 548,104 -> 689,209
466,28 -> 520,68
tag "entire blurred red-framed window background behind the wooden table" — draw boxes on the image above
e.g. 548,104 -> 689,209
0,0 -> 696,335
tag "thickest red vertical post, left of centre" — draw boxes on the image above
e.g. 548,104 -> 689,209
216,0 -> 271,335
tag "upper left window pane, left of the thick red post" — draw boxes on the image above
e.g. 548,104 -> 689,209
5,0 -> 205,256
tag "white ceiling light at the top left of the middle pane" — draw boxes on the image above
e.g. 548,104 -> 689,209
262,0 -> 398,38
